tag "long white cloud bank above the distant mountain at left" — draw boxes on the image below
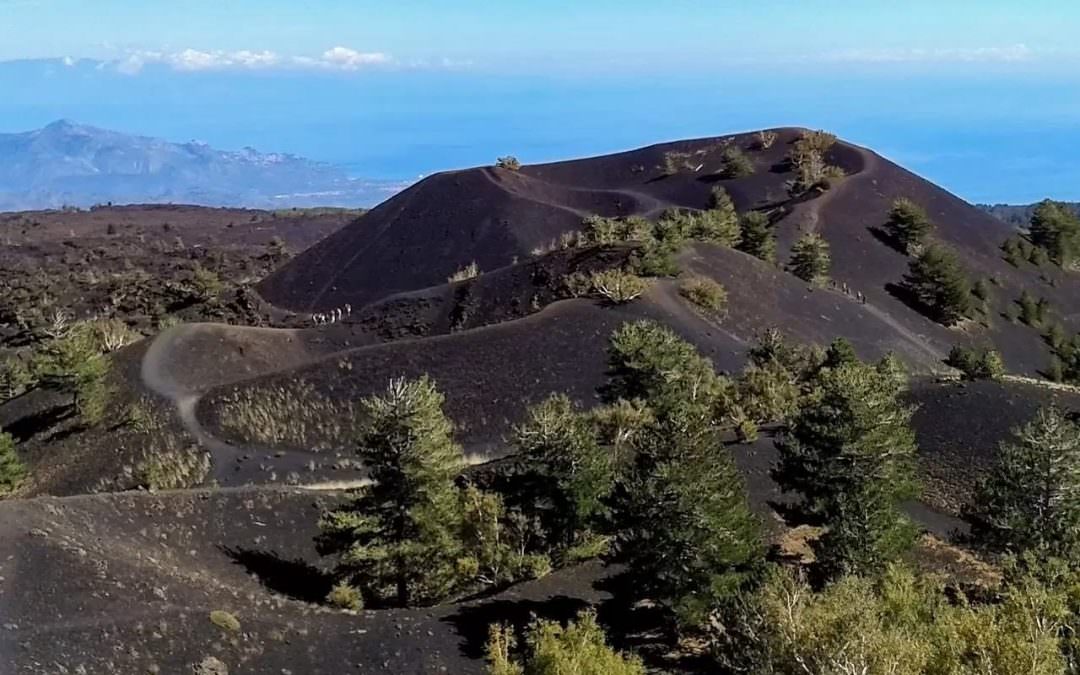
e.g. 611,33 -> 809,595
111,46 -> 394,75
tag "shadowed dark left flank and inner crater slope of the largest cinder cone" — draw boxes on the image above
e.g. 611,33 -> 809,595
259,126 -> 796,311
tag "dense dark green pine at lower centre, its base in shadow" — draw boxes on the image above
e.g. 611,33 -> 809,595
621,432 -> 764,626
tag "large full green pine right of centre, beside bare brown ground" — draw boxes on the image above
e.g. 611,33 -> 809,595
774,363 -> 916,579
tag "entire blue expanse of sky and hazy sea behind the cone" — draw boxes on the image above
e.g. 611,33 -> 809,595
0,0 -> 1080,201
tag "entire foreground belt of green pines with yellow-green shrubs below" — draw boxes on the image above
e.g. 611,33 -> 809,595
319,321 -> 1080,675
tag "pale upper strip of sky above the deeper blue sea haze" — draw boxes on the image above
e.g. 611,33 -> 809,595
8,0 -> 1080,72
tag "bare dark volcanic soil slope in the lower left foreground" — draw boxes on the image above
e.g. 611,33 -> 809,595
0,488 -> 605,675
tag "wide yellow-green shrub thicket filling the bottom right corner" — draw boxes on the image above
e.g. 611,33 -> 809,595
747,565 -> 1076,675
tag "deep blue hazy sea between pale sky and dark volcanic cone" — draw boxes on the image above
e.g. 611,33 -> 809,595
6,62 -> 1080,203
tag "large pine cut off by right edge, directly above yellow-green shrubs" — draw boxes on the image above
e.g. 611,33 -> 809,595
969,407 -> 1080,559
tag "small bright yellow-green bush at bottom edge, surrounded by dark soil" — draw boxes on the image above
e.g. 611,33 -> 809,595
485,611 -> 645,675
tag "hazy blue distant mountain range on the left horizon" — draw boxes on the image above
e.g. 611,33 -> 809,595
0,120 -> 405,211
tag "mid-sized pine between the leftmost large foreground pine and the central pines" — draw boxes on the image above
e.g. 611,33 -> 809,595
515,394 -> 615,545
